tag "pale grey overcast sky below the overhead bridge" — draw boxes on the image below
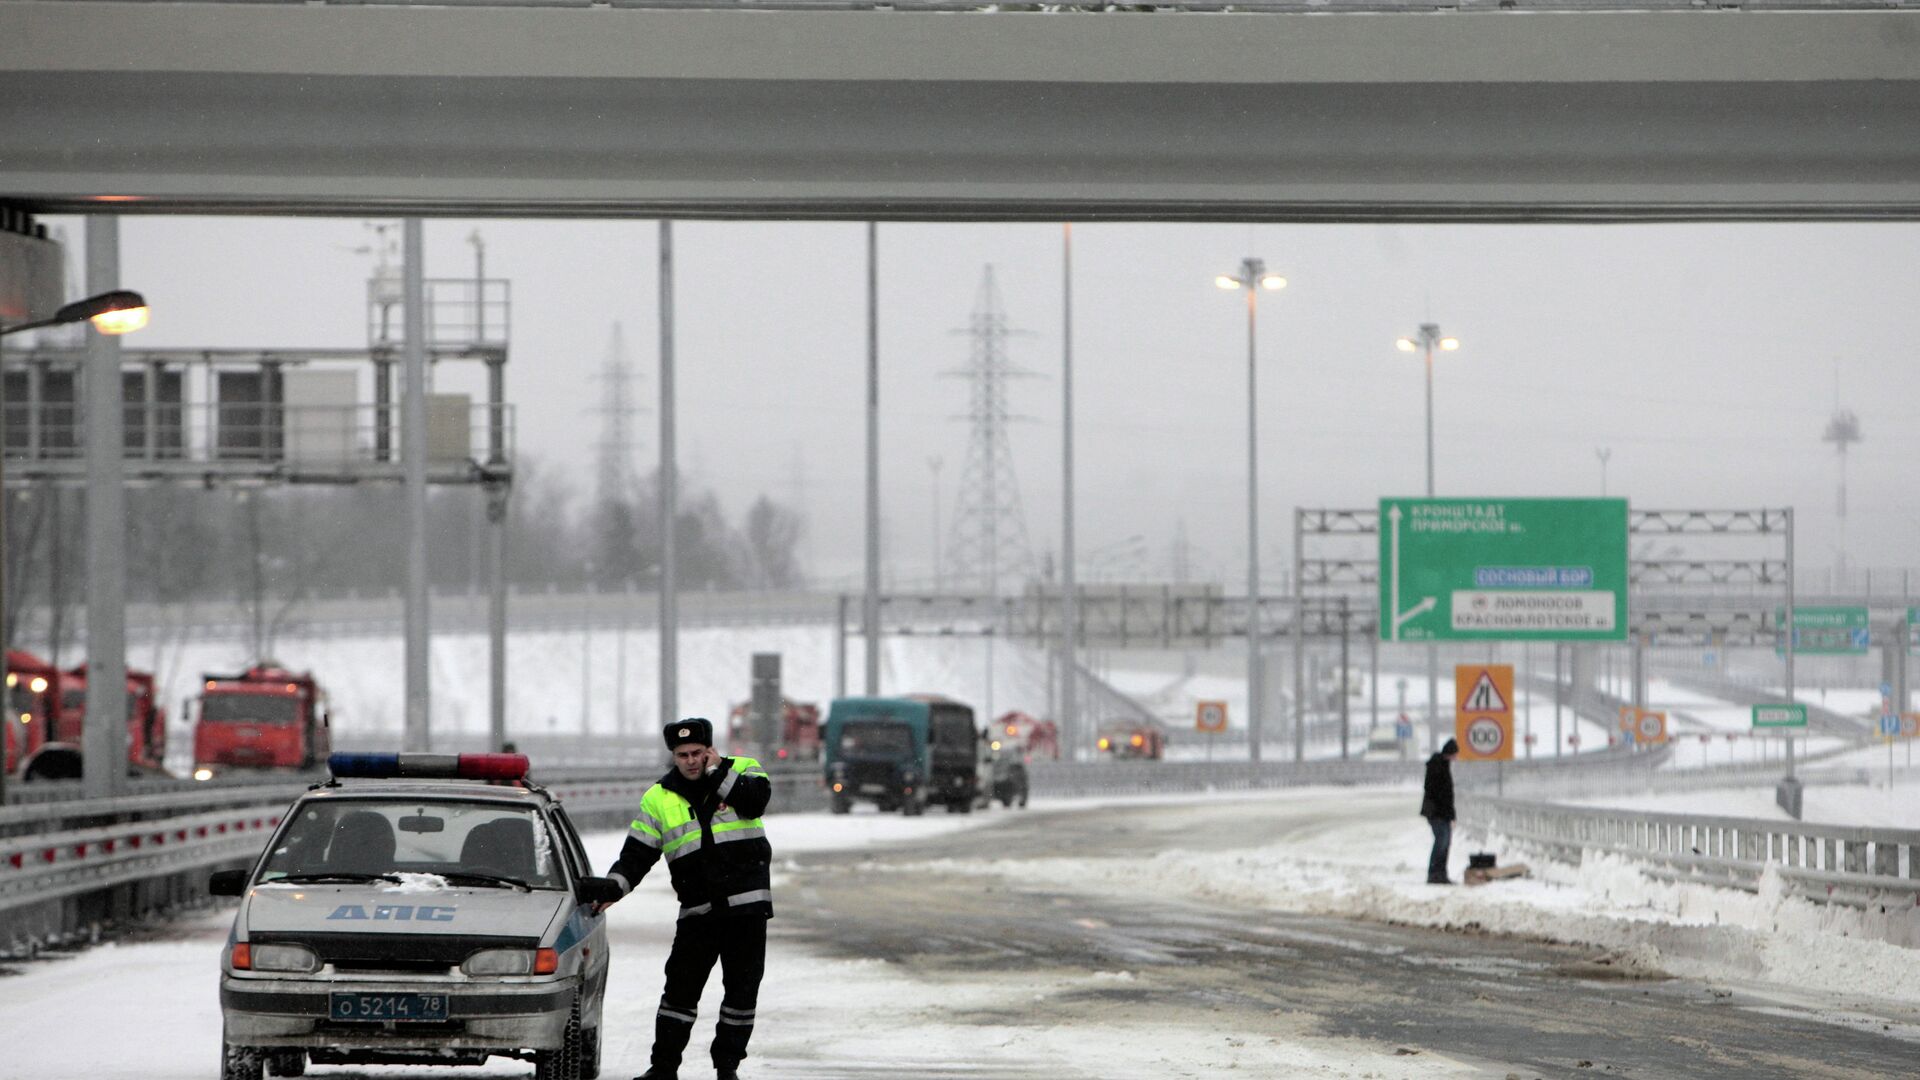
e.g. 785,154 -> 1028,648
56,217 -> 1920,582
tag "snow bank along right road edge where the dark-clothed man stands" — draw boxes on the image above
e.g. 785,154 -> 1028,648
929,790 -> 1920,1005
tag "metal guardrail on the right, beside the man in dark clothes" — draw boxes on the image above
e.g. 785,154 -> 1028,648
1461,798 -> 1920,907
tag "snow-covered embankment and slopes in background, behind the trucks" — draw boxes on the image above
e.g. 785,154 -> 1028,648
132,626 -> 1904,774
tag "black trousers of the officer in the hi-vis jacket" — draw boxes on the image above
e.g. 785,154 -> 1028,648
653,915 -> 766,1070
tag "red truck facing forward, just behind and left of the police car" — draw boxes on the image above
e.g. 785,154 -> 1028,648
194,661 -> 332,780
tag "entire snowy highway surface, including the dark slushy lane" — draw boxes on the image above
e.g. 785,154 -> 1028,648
0,790 -> 1920,1080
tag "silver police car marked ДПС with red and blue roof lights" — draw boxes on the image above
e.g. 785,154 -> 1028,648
209,753 -> 620,1080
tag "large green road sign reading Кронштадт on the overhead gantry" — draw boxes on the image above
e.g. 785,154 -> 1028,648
1380,500 -> 1626,642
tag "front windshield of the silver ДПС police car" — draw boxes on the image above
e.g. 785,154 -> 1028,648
259,798 -> 566,890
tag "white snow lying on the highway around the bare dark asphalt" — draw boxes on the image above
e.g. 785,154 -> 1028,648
0,788 -> 1920,1080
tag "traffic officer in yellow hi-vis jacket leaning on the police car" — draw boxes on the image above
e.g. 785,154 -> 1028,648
607,719 -> 774,1080
